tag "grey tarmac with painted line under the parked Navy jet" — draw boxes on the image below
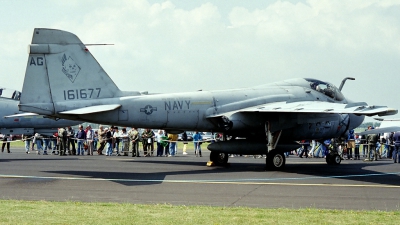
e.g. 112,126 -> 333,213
0,149 -> 400,210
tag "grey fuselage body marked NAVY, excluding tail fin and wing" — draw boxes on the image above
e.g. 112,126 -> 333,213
51,81 -> 364,140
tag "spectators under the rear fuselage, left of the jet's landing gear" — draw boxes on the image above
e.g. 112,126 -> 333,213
14,125 -> 203,157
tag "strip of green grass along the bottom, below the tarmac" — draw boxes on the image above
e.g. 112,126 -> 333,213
0,200 -> 400,225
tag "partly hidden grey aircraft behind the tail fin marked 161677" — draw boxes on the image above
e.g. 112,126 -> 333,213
0,87 -> 79,136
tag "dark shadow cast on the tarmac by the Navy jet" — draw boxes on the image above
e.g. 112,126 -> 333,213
44,160 -> 400,186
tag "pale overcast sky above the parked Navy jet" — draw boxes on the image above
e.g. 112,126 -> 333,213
0,0 -> 400,121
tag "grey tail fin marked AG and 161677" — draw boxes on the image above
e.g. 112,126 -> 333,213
20,28 -> 122,115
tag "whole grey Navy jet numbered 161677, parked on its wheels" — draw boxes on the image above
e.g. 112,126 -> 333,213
19,28 -> 397,169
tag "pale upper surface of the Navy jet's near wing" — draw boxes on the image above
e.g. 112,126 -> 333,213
238,101 -> 397,116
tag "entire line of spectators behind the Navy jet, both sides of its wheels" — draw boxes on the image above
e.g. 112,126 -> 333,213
2,125 -> 400,163
